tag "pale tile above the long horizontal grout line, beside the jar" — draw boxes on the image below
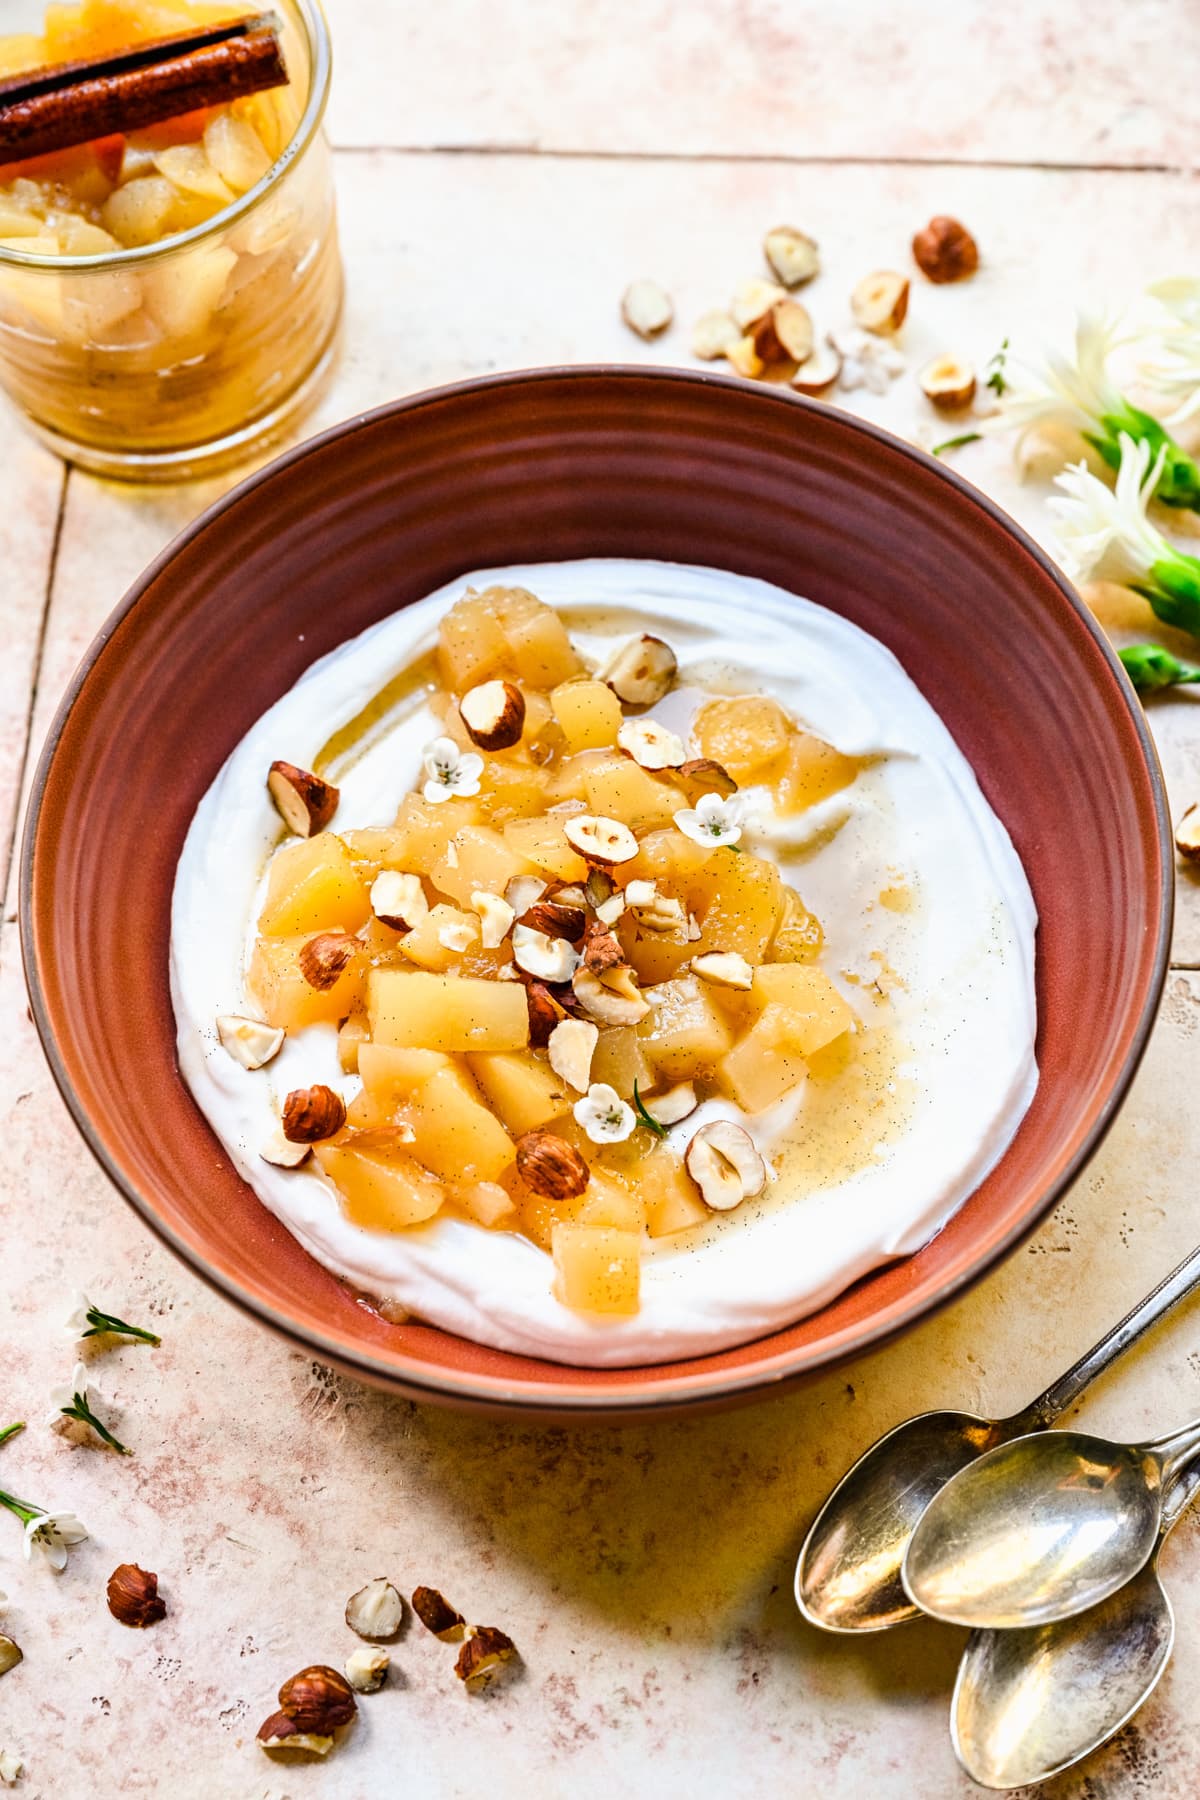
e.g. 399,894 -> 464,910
327,0 -> 1200,169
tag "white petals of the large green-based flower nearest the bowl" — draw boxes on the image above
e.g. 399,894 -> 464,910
1047,432 -> 1175,583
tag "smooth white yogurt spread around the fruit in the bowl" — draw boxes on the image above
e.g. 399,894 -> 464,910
171,562 -> 1038,1368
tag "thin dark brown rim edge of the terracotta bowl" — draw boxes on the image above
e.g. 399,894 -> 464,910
20,364 -> 1175,1417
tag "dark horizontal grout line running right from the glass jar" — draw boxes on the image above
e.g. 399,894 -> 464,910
333,140 -> 1198,176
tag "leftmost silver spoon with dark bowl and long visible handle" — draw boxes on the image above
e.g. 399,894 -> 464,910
795,1249 -> 1200,1633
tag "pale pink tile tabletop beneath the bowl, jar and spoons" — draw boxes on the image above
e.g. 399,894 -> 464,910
0,10 -> 1200,1800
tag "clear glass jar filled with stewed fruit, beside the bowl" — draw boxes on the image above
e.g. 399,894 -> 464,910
0,0 -> 342,481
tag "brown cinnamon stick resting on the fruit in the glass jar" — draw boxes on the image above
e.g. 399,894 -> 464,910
0,13 -> 288,164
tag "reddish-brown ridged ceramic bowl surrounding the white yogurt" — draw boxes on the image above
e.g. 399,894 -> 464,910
22,367 -> 1173,1413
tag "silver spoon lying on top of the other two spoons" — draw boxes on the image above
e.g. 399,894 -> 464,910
900,1420 -> 1200,1631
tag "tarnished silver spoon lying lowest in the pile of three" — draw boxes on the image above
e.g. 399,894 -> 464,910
950,1469 -> 1200,1787
